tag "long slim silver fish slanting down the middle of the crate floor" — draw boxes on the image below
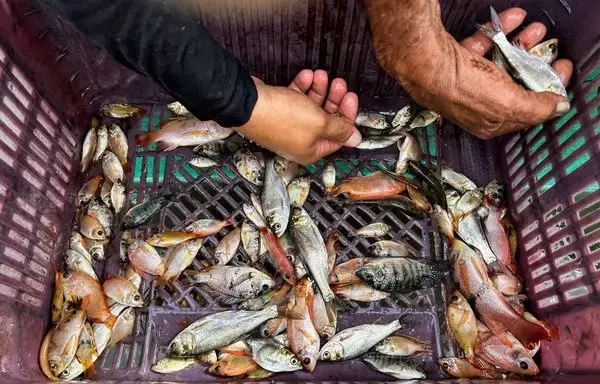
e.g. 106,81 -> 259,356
291,205 -> 334,301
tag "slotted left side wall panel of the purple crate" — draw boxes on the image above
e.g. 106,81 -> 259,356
0,42 -> 79,307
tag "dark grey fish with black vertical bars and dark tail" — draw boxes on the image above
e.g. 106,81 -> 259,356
356,257 -> 449,293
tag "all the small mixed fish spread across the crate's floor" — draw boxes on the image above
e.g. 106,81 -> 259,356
40,97 -> 555,379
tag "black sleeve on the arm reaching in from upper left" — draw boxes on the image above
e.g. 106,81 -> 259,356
43,0 -> 257,127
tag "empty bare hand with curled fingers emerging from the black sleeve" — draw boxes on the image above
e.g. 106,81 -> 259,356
235,70 -> 362,165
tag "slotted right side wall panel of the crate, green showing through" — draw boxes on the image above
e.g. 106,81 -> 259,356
504,47 -> 600,312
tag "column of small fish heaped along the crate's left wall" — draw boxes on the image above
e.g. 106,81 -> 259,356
39,104 -> 155,380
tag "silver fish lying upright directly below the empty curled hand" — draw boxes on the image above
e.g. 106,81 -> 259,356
261,158 -> 290,237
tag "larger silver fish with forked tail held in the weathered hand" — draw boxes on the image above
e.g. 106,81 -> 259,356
477,7 -> 567,97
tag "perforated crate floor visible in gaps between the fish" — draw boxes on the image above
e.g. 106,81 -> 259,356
88,107 -> 454,381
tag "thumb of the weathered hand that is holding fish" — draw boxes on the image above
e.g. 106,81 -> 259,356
514,90 -> 571,125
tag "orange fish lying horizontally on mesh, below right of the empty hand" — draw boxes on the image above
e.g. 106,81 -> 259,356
328,172 -> 406,200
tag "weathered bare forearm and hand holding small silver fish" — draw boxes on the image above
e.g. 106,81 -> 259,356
365,0 -> 573,139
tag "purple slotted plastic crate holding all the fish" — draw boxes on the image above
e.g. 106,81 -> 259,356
0,0 -> 600,383
